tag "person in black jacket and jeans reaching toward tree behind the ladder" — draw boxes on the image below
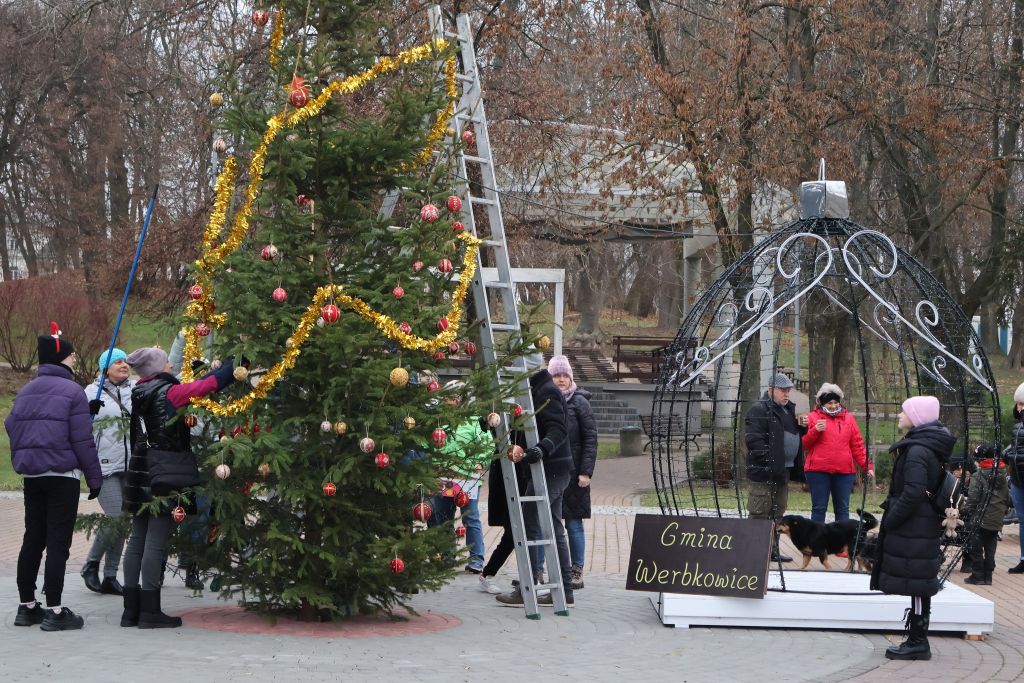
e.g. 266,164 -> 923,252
496,352 -> 574,606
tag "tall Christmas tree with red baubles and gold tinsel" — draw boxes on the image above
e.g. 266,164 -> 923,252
179,0 -> 522,620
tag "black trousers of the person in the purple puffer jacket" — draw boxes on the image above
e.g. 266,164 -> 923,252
17,476 -> 79,607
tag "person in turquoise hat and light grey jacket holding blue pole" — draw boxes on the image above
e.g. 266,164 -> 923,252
82,348 -> 135,595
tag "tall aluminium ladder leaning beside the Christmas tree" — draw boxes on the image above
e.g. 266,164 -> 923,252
429,5 -> 568,620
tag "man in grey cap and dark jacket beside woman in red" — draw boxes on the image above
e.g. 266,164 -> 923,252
743,373 -> 807,562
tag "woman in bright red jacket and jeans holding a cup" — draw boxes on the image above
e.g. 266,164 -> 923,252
803,382 -> 874,522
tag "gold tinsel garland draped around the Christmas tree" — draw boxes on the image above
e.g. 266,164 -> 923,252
181,41 -> 480,417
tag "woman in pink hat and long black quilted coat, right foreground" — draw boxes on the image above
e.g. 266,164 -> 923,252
871,396 -> 956,659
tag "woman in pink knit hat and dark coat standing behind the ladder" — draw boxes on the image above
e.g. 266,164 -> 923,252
548,355 -> 597,591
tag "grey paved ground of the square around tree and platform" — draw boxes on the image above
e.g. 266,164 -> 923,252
0,458 -> 1024,683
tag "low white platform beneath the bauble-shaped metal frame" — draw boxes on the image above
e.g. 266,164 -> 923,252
651,571 -> 995,636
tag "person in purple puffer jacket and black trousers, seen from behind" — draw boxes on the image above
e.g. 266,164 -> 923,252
4,323 -> 103,631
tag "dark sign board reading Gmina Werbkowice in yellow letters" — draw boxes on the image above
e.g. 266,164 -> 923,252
626,515 -> 772,598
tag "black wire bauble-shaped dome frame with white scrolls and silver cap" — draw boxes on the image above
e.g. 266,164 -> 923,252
651,165 -> 999,585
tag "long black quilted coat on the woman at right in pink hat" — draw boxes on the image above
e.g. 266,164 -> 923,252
871,422 -> 956,597
